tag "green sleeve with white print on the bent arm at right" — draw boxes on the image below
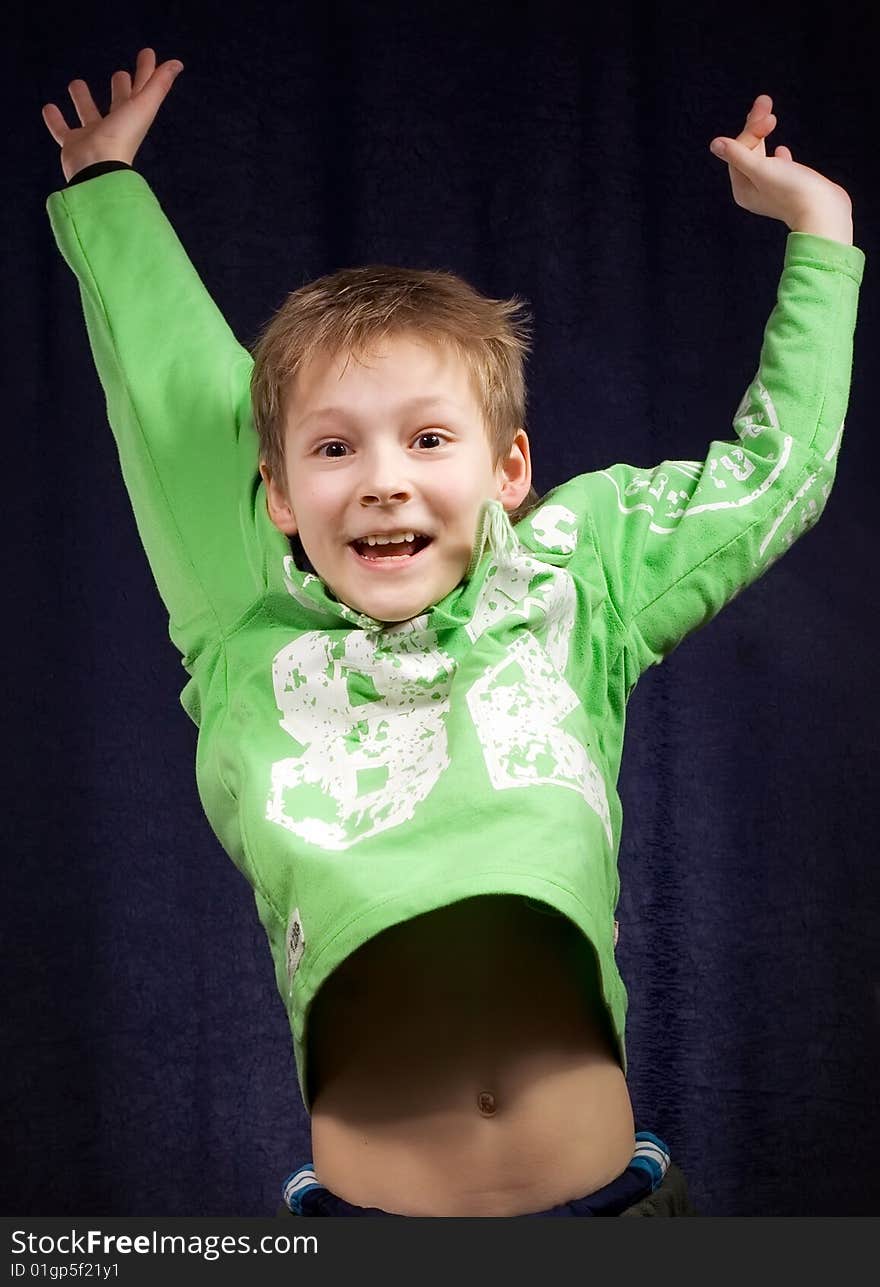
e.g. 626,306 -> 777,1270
581,233 -> 865,673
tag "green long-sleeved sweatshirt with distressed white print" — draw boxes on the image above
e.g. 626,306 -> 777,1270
46,170 -> 865,1111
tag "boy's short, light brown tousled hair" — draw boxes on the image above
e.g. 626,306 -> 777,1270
251,264 -> 540,523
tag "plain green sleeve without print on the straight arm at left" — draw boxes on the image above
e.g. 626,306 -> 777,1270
46,170 -> 262,665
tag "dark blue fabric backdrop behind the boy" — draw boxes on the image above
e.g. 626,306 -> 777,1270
6,0 -> 880,1216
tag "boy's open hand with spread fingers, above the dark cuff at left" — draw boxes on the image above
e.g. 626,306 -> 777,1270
42,49 -> 183,183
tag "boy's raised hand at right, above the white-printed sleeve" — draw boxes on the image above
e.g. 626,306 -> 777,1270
710,94 -> 853,241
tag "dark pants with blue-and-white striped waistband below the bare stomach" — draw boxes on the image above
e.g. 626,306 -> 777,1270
278,1131 -> 700,1219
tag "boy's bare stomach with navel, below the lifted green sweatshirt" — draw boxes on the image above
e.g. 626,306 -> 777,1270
303,894 -> 636,1216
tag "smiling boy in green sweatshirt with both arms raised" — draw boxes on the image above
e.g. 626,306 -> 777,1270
44,50 -> 865,1216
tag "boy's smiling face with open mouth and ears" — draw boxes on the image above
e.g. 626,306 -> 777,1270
260,335 -> 531,622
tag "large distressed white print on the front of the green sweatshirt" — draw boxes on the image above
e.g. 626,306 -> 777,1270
266,506 -> 611,849
